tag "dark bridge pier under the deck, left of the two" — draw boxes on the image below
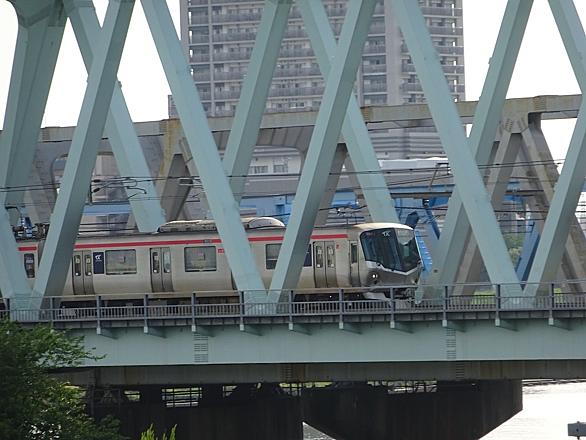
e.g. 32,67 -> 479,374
90,384 -> 303,440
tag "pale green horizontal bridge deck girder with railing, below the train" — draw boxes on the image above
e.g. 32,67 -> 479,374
9,288 -> 586,385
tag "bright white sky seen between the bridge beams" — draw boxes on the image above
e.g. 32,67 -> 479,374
0,0 -> 586,159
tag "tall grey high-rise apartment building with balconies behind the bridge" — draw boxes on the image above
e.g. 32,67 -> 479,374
178,0 -> 464,116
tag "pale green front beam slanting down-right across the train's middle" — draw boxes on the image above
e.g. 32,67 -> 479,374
142,0 -> 267,302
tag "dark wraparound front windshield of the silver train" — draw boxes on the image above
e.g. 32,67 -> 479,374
360,228 -> 419,272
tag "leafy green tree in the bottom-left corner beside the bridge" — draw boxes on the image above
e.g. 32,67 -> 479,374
0,320 -> 125,440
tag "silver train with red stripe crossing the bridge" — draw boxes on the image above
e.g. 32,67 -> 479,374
19,217 -> 421,301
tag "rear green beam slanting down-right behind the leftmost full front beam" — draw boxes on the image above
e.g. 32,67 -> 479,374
64,0 -> 165,232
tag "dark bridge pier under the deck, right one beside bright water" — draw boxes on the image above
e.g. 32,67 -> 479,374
302,380 -> 523,440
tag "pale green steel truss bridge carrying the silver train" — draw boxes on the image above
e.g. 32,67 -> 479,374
0,0 -> 586,384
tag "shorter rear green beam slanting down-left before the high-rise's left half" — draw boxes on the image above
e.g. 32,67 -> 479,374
224,0 -> 292,202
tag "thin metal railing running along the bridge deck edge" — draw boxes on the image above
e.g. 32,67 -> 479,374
0,280 -> 586,333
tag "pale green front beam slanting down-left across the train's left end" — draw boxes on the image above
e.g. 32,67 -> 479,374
31,0 -> 134,307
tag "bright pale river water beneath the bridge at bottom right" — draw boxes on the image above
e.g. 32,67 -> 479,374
304,383 -> 586,440
